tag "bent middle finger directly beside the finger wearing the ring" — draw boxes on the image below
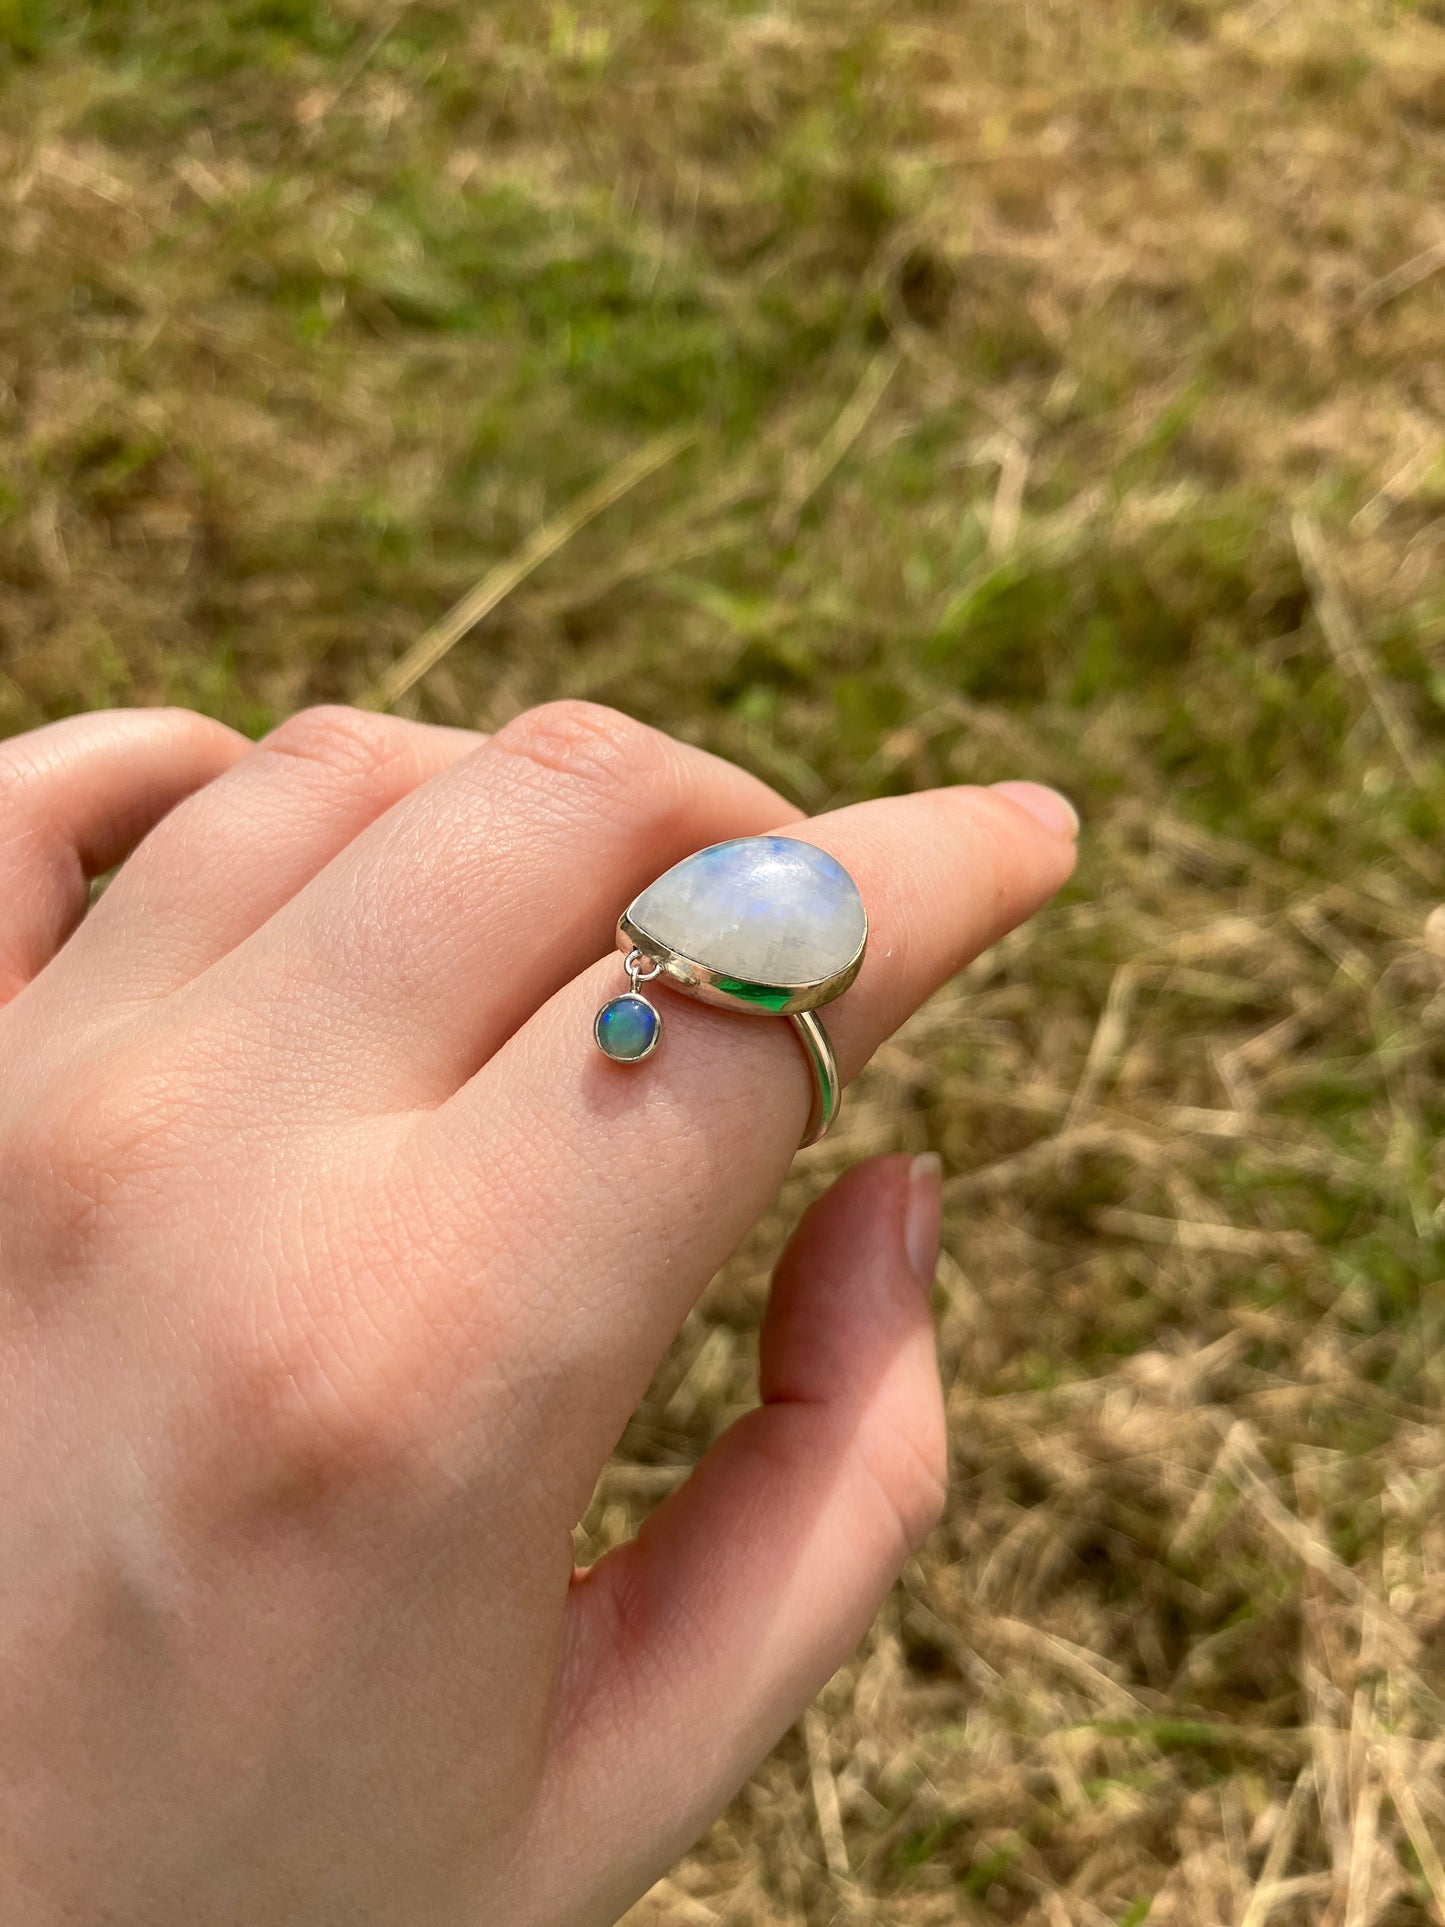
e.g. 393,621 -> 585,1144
193,701 -> 798,1114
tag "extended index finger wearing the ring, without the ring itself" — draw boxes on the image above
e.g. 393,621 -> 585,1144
414,788 -> 1075,1465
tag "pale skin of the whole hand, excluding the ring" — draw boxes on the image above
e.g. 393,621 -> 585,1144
0,703 -> 1073,1927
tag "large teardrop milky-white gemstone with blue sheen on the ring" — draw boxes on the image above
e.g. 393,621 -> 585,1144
628,836 -> 867,987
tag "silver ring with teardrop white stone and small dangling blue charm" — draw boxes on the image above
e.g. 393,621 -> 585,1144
591,836 -> 869,1145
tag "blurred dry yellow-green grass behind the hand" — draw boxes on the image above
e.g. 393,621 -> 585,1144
0,0 -> 1445,1927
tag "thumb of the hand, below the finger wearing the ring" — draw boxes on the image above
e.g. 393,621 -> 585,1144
531,1156 -> 946,1923
